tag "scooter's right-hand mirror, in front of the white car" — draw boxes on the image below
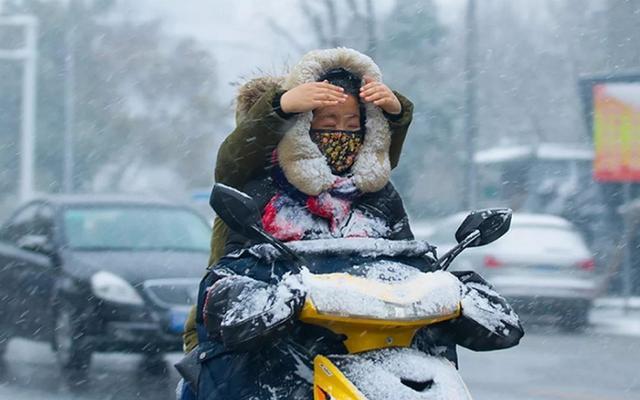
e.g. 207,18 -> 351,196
456,208 -> 513,247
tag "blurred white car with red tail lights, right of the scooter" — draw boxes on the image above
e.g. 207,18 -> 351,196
418,213 -> 600,330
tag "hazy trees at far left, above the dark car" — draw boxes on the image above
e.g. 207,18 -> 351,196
0,0 -> 228,205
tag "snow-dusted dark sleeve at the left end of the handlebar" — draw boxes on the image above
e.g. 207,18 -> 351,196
203,276 -> 304,350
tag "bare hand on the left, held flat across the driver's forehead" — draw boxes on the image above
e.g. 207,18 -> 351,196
280,81 -> 348,114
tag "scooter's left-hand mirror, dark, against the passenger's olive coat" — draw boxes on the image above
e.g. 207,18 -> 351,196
209,183 -> 264,242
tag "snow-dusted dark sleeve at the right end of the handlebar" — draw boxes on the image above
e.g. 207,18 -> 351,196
442,271 -> 524,351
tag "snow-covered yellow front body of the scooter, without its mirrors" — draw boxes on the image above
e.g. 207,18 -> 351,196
299,267 -> 471,400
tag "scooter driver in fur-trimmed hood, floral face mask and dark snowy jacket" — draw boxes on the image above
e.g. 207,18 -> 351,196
179,49 -> 522,399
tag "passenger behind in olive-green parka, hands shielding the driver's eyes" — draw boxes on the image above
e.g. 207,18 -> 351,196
183,47 -> 413,352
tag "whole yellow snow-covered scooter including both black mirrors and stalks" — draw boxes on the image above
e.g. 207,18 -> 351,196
202,185 -> 511,400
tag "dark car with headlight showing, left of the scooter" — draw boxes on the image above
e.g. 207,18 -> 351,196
0,195 -> 211,376
